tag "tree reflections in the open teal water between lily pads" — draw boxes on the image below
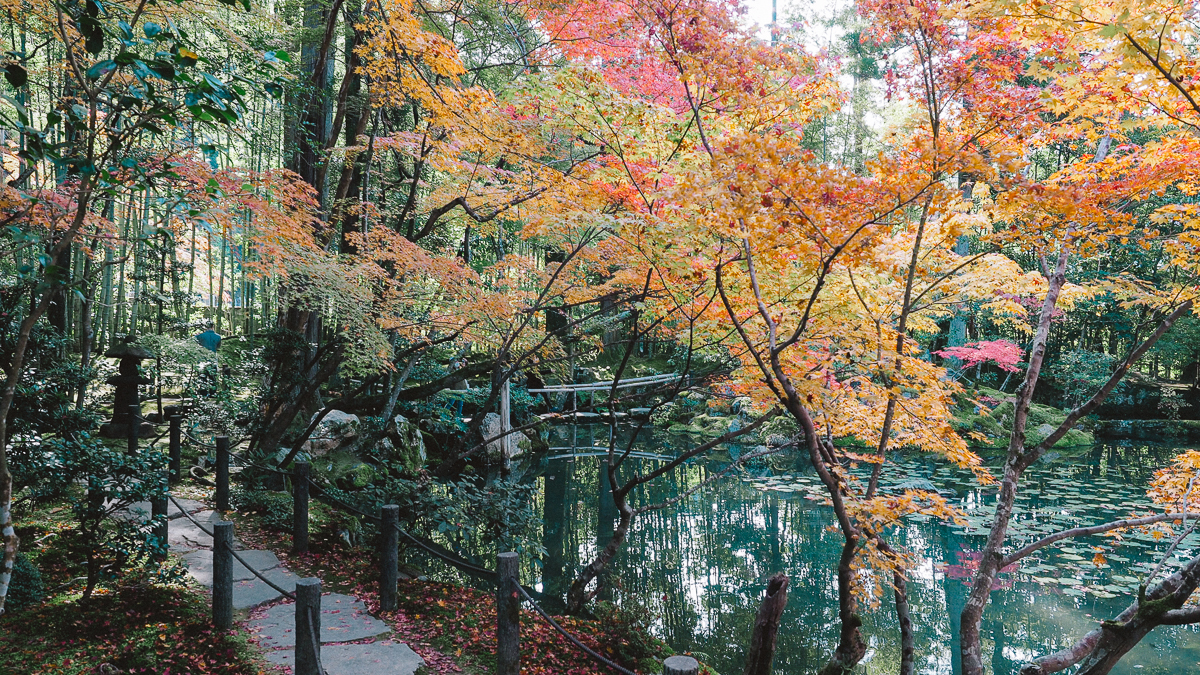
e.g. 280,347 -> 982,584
536,428 -> 1200,675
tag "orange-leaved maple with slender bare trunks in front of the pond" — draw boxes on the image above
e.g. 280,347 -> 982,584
523,2 -> 1194,673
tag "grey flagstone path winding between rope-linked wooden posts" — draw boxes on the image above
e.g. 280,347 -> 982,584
127,492 -> 425,675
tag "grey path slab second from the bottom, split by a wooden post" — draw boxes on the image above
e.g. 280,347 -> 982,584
254,591 -> 391,648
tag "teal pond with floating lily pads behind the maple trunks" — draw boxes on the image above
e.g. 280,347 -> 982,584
530,425 -> 1200,675
